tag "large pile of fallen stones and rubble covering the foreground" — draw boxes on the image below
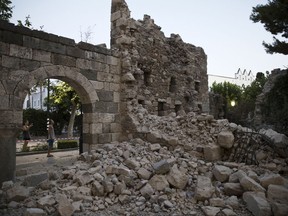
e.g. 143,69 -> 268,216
0,109 -> 288,216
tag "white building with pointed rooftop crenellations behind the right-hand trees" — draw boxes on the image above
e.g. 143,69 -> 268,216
208,68 -> 255,88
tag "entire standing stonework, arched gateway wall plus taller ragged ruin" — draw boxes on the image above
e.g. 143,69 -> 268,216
0,0 -> 209,186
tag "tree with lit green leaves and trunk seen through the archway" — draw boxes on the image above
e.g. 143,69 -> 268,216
50,81 -> 80,138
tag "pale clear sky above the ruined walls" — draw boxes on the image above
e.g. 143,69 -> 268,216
10,0 -> 288,77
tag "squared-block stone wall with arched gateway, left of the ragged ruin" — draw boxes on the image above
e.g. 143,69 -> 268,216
0,22 -> 121,184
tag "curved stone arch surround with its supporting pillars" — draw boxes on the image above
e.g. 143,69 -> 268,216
0,65 -> 99,186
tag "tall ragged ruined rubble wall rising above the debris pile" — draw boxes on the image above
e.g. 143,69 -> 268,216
111,0 -> 209,124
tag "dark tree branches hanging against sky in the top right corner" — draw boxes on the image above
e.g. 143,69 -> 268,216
250,0 -> 288,55
